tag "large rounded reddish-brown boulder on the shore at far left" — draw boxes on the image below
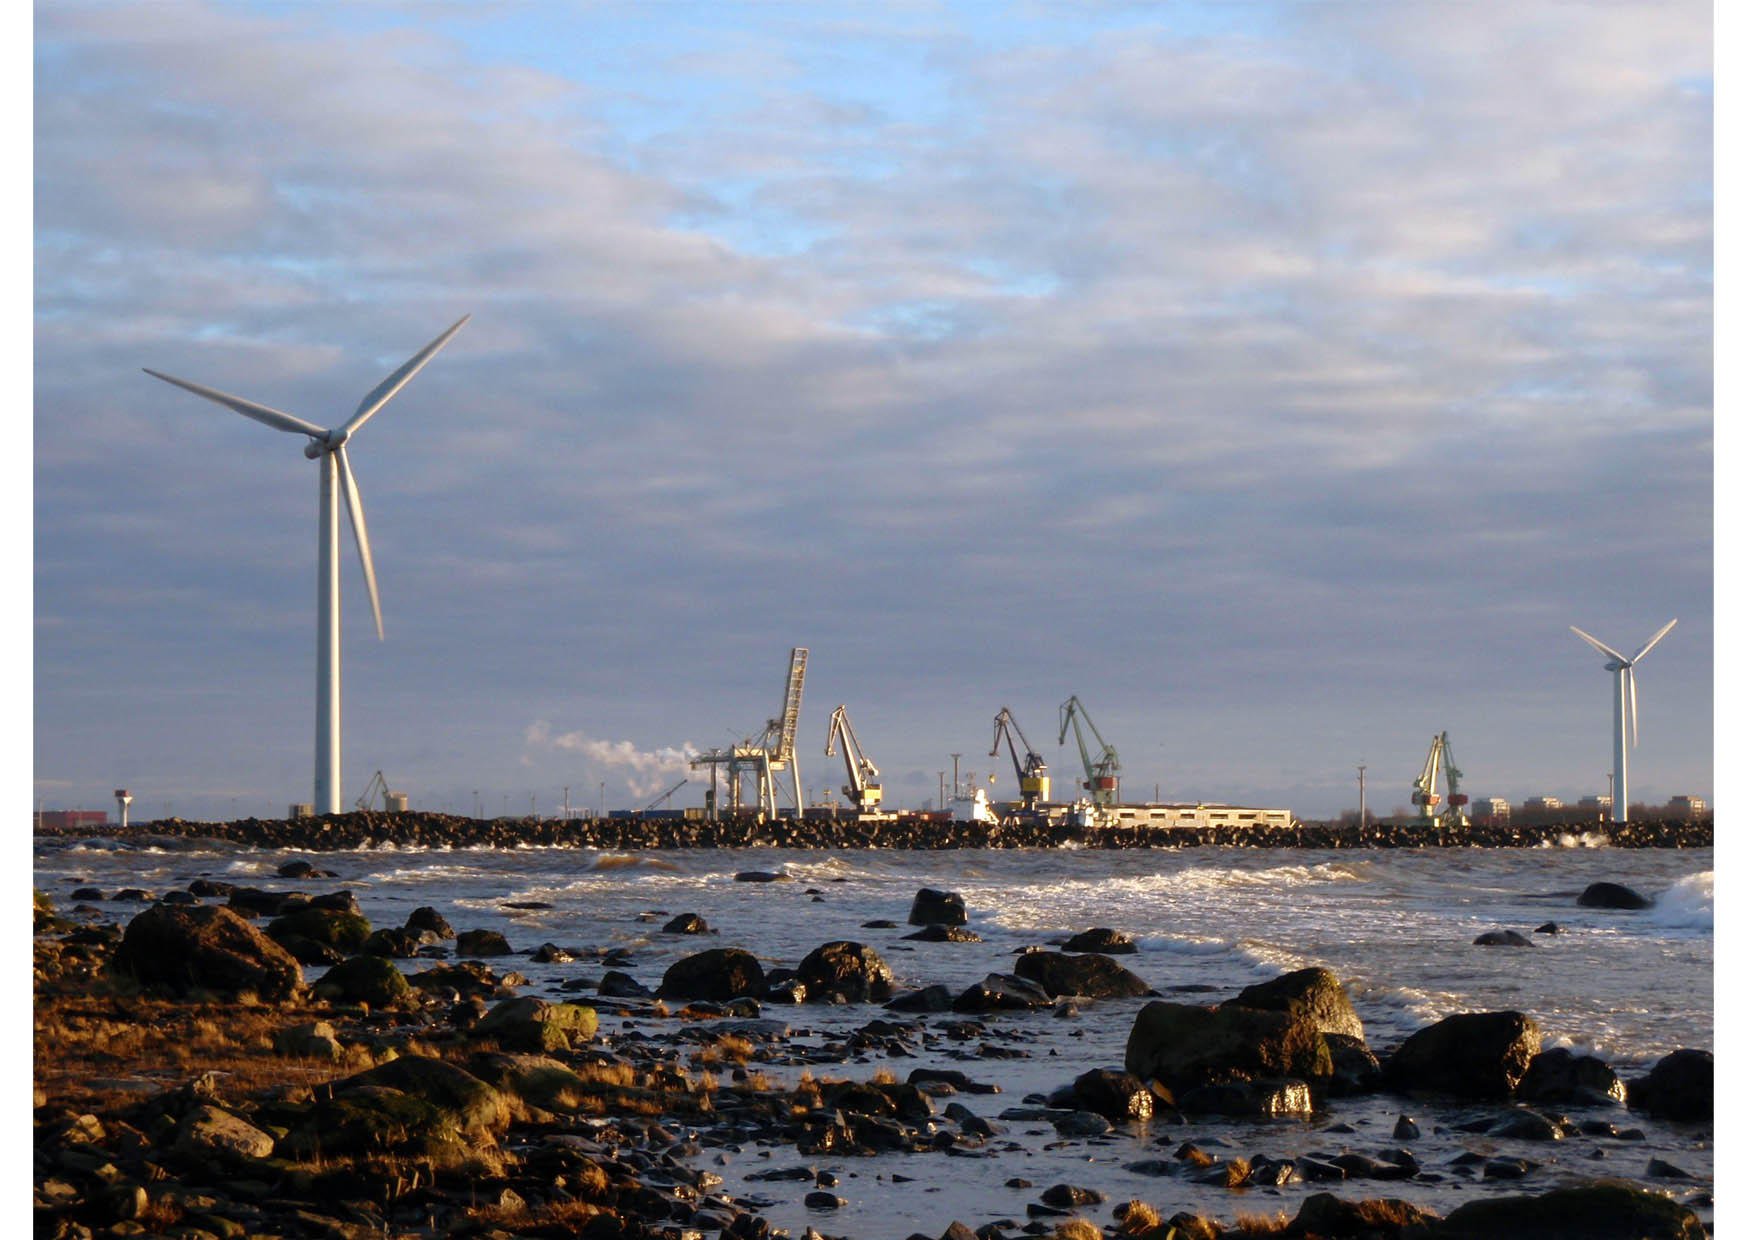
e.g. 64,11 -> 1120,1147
112,904 -> 301,1002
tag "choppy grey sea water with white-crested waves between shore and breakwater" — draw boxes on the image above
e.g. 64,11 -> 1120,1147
37,836 -> 1713,1240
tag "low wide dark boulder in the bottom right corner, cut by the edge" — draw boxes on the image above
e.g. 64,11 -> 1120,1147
1432,1181 -> 1706,1240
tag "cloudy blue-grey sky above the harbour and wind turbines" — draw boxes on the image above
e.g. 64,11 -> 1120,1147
33,0 -> 1713,817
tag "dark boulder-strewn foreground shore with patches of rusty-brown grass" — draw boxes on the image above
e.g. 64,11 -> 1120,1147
33,870 -> 1713,1240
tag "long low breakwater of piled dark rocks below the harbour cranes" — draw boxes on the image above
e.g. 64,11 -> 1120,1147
64,812 -> 1713,852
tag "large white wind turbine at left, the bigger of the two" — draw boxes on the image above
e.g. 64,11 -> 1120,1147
142,315 -> 469,813
